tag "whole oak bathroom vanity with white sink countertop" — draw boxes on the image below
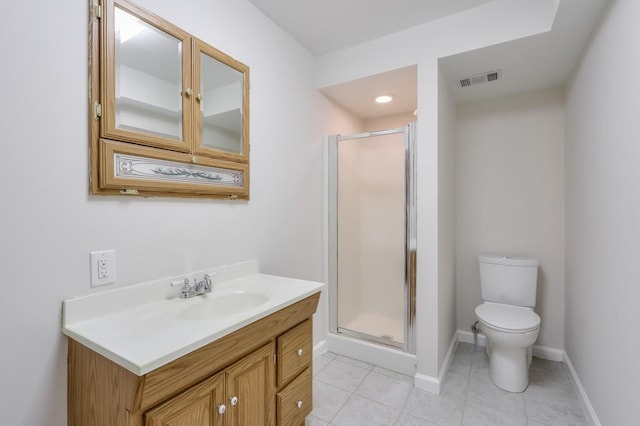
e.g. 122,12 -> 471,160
63,264 -> 323,426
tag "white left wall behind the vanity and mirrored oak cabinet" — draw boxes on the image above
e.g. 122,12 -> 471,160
0,0 -> 340,426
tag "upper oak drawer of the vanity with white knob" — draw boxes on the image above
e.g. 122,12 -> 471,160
278,319 -> 313,386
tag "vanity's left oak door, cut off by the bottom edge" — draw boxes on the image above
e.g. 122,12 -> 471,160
144,373 -> 225,426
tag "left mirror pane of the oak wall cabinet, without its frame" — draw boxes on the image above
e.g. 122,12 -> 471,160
115,7 -> 183,140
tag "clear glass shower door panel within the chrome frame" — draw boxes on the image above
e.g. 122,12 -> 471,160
334,125 -> 411,349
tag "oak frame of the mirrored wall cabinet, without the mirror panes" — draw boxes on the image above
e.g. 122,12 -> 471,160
88,0 -> 249,199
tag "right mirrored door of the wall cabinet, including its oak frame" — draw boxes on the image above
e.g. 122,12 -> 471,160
193,41 -> 248,161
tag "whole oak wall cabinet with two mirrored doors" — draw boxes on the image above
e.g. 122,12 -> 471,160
89,0 -> 249,199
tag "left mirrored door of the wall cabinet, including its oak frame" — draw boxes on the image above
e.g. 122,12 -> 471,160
105,3 -> 193,151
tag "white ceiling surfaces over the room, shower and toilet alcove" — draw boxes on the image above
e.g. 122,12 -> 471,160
249,0 -> 609,119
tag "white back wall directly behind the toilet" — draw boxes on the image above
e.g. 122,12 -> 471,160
456,89 -> 565,351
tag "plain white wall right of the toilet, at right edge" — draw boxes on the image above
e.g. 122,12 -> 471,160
565,0 -> 640,426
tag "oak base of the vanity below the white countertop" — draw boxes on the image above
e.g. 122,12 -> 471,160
68,293 -> 320,426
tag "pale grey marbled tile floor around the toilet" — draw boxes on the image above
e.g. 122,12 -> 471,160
306,343 -> 588,426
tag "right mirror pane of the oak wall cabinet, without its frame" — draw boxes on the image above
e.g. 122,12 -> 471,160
200,53 -> 244,154
